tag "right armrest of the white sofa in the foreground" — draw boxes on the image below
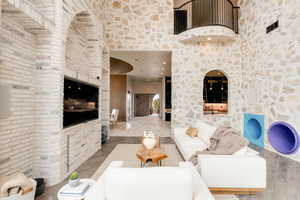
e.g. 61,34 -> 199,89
179,162 -> 215,200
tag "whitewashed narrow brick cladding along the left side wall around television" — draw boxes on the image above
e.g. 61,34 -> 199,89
0,0 -> 109,185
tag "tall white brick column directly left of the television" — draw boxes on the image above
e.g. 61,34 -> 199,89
34,0 -> 64,186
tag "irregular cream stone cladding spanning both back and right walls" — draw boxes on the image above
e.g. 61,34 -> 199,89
105,0 -> 300,161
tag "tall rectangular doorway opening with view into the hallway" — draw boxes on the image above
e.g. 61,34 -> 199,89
110,51 -> 172,136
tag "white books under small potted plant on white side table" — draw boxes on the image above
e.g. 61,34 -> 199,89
58,182 -> 90,197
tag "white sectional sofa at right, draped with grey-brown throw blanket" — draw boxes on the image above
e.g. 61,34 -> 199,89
173,121 -> 266,194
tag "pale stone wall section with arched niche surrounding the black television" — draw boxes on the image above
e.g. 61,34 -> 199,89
59,0 -> 109,184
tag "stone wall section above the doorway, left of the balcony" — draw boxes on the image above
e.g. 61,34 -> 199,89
106,0 -> 173,50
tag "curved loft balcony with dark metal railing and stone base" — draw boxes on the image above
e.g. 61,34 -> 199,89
174,0 -> 239,41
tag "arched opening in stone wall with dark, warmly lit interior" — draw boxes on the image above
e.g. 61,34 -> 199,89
203,70 -> 228,115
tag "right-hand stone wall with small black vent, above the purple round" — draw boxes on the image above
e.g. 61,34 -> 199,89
240,0 -> 300,161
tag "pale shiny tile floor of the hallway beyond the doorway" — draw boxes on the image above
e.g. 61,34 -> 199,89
110,115 -> 171,137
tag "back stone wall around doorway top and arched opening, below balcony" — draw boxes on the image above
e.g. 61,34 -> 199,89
106,0 -> 242,129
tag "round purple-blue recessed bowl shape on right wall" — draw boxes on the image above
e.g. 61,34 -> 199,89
268,121 -> 300,154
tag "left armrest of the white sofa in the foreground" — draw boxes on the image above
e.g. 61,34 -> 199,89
85,161 -> 124,200
